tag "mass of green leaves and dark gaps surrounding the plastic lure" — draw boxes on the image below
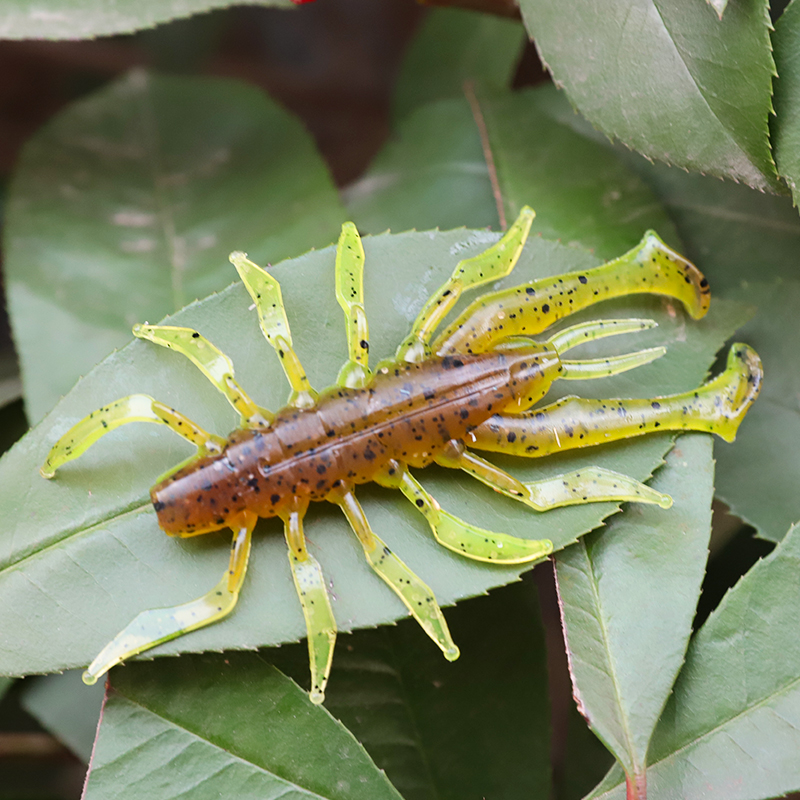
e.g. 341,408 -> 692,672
0,0 -> 800,800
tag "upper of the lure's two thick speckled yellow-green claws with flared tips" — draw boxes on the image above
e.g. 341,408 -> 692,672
432,231 -> 710,356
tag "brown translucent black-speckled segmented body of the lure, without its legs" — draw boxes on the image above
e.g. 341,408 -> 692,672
150,343 -> 561,536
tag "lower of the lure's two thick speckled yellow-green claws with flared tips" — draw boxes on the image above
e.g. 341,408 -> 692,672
470,344 -> 763,458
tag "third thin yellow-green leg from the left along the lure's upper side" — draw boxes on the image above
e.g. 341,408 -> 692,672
229,252 -> 317,408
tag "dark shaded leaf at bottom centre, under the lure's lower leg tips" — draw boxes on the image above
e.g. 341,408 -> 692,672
272,580 -> 550,800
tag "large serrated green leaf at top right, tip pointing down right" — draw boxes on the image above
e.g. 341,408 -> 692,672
520,0 -> 780,191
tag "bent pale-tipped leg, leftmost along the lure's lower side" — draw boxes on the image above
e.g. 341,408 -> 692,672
83,513 -> 258,685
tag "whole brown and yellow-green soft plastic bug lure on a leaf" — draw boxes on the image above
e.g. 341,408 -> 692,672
41,207 -> 762,703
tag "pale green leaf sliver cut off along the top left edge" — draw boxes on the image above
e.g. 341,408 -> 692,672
0,0 -> 291,39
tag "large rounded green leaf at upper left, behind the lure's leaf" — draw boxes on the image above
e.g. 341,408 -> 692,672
5,72 -> 344,420
